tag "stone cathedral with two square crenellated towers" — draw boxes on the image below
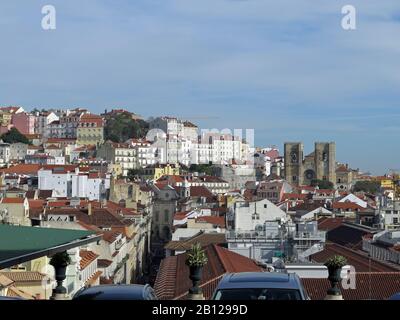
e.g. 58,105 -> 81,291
285,142 -> 336,186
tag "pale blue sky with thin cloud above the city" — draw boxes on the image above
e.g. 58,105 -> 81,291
0,0 -> 400,174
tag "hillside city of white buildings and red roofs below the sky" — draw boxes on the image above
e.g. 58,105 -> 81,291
0,106 -> 400,300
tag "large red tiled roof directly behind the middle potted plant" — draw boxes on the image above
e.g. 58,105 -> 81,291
154,245 -> 263,300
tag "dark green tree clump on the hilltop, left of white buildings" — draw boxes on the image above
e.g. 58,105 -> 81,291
104,113 -> 149,142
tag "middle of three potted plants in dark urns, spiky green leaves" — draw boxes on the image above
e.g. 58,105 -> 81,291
186,243 -> 208,294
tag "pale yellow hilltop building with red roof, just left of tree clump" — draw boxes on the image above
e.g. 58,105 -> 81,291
76,114 -> 104,145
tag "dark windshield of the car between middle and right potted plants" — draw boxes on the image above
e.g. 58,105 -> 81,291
215,288 -> 302,300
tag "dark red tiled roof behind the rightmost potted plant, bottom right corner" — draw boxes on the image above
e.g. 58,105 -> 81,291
302,272 -> 400,300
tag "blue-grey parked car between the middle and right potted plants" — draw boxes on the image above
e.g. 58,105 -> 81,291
212,272 -> 309,300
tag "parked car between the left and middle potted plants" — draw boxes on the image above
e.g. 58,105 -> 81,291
72,284 -> 158,300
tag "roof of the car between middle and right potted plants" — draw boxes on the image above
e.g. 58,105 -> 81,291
217,272 -> 301,289
